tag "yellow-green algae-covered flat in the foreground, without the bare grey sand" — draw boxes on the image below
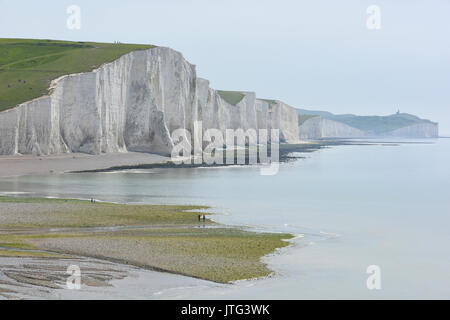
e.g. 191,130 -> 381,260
0,197 -> 292,283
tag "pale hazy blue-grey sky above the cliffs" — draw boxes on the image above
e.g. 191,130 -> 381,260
0,0 -> 450,135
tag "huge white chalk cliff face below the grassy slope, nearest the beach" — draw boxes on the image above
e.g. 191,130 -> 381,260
0,47 -> 299,155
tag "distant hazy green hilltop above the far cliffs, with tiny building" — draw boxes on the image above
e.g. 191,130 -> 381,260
297,109 -> 434,134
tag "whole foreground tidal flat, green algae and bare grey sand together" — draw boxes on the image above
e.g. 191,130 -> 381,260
0,197 -> 291,299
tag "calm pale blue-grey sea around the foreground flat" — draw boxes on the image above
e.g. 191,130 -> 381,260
0,139 -> 450,299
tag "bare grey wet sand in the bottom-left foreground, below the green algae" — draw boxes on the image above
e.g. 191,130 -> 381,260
0,257 -> 214,300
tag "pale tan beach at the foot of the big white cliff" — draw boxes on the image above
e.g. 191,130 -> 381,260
0,152 -> 170,178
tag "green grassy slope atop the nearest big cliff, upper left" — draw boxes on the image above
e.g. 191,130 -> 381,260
0,38 -> 153,111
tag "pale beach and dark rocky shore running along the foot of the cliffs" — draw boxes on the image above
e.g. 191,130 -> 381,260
0,139 -> 427,179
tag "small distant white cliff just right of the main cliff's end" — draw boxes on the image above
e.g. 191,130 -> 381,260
299,117 -> 366,139
